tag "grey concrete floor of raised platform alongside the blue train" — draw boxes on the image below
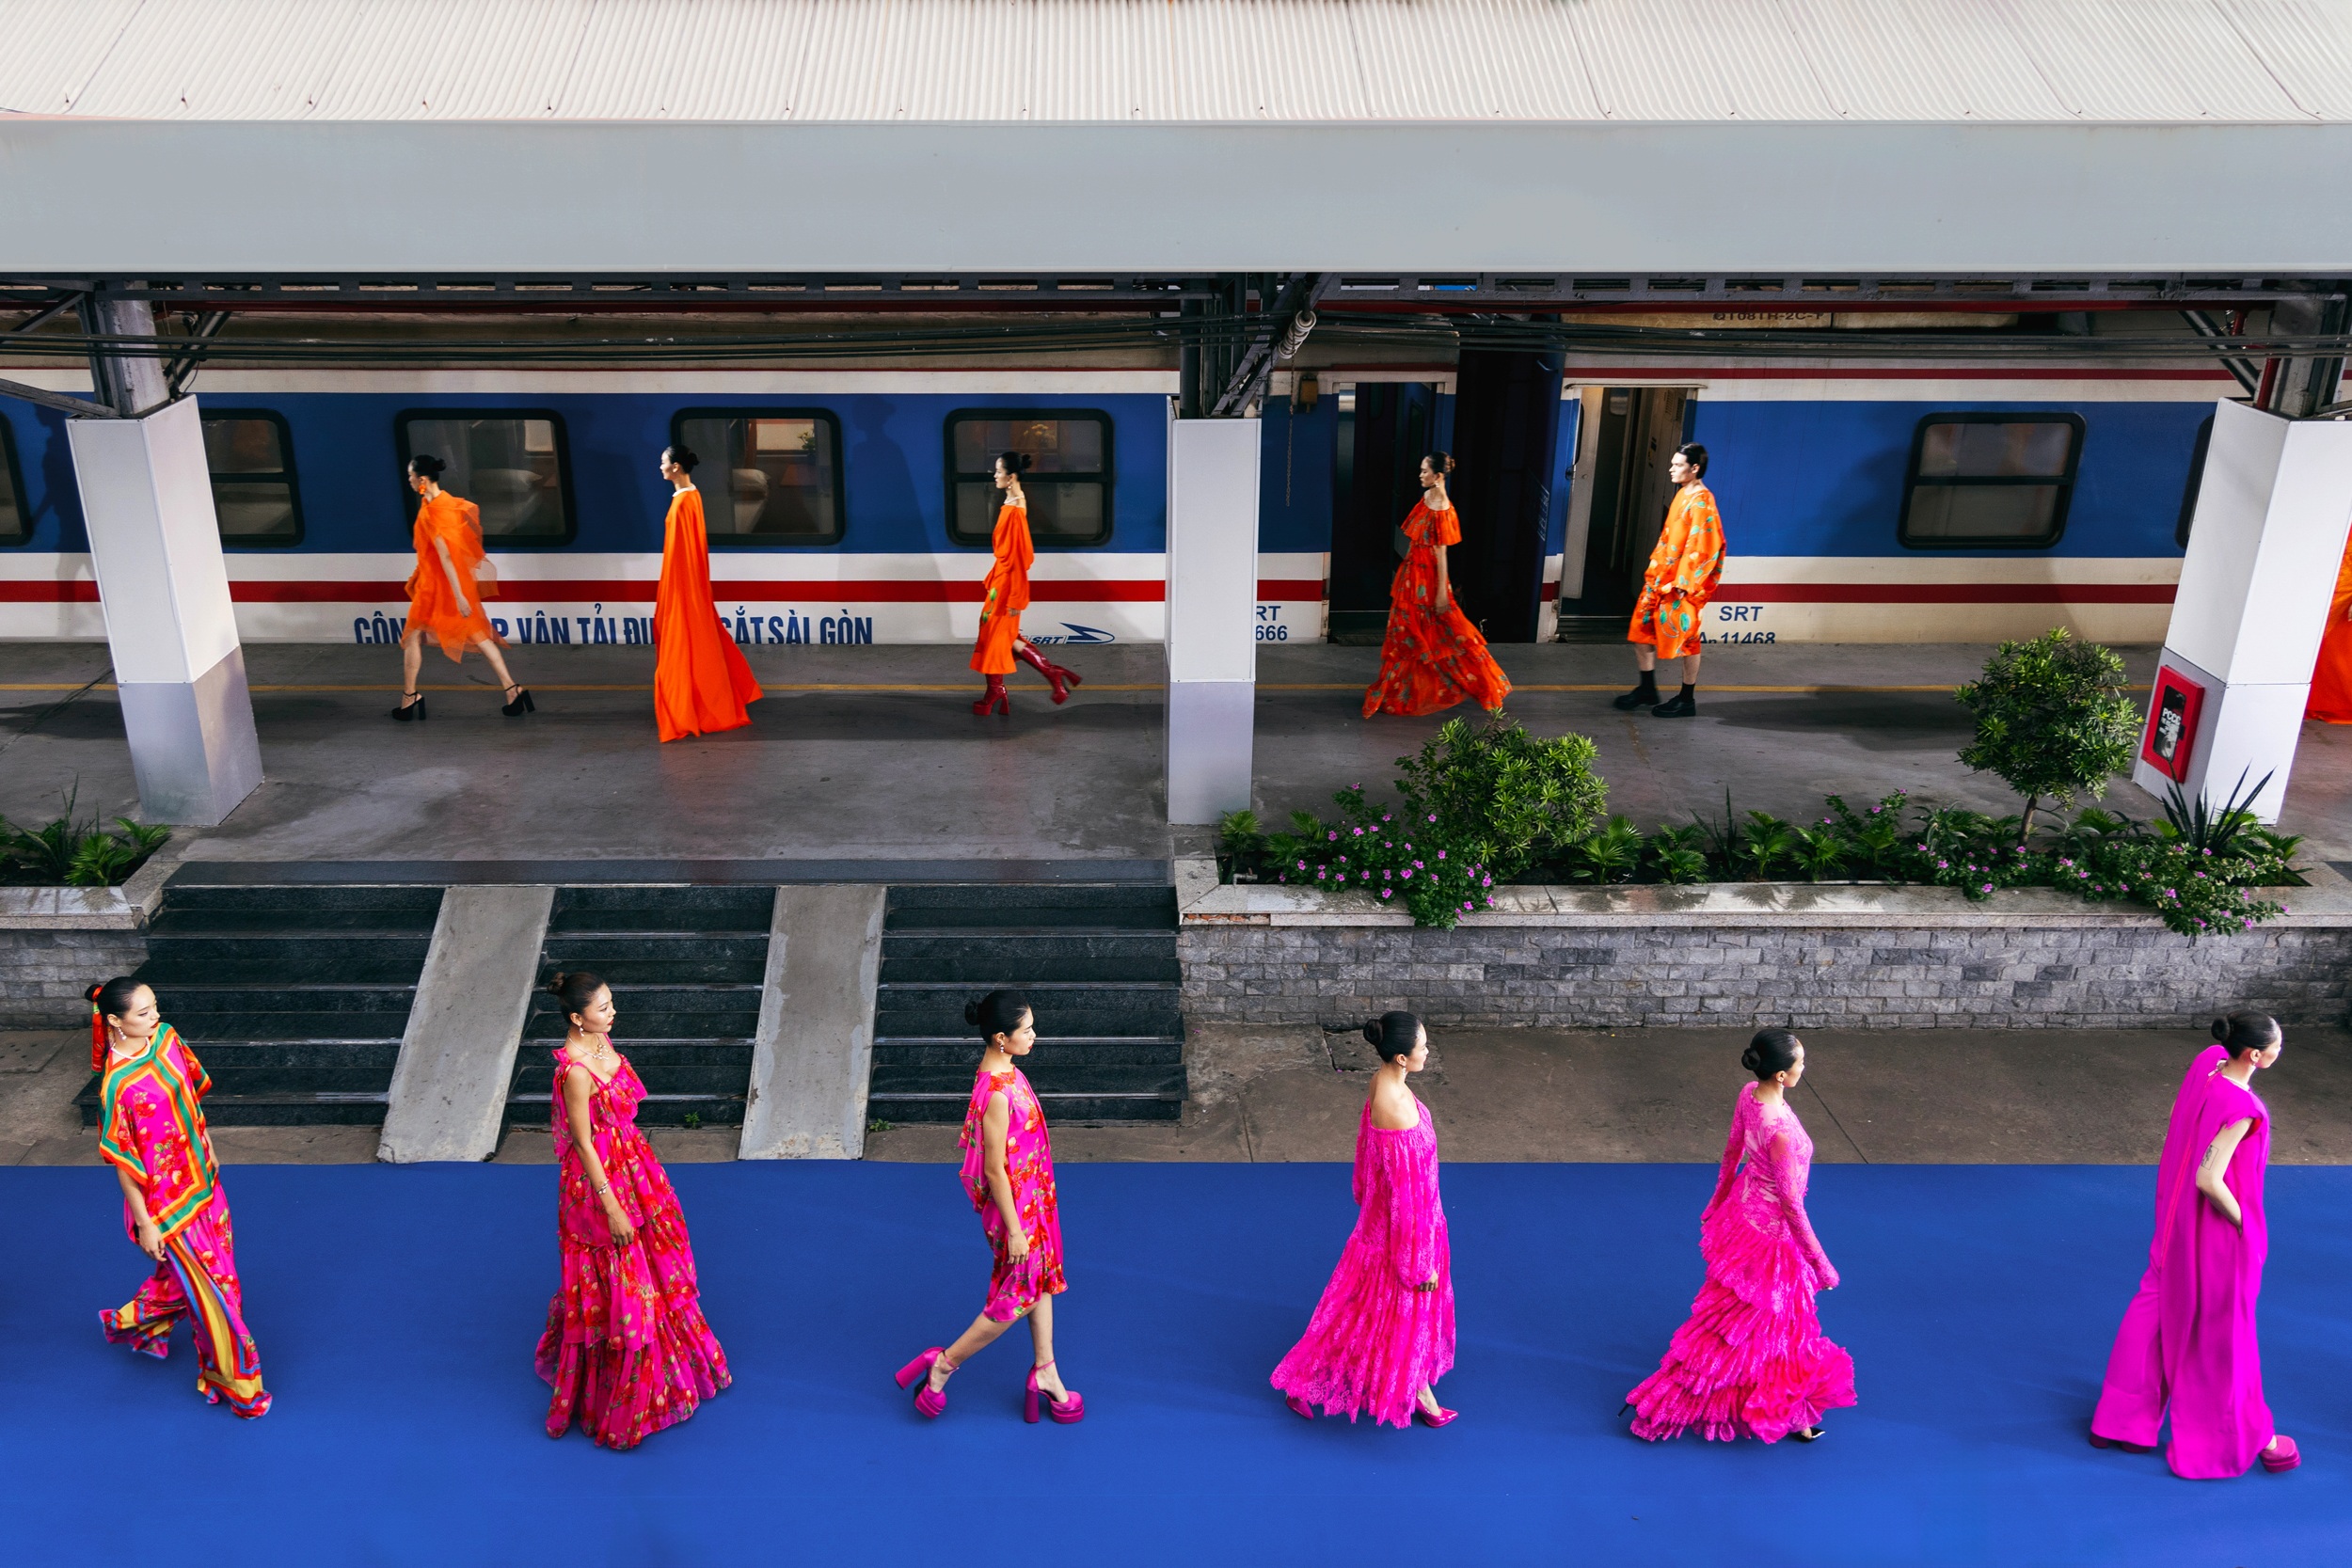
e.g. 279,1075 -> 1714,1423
0,644 -> 2352,861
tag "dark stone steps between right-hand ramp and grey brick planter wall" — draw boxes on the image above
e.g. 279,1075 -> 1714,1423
866,884 -> 1185,1121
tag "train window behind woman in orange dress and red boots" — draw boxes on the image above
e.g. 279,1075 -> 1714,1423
948,409 -> 1110,546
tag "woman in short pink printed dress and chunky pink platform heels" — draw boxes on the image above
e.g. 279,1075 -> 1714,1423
898,990 -> 1087,1425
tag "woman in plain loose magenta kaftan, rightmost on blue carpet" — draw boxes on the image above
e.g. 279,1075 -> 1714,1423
2091,1013 -> 2303,1481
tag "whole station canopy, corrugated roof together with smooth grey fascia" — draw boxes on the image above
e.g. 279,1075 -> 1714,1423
13,0 -> 2352,279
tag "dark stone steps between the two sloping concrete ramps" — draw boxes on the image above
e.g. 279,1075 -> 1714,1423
506,886 -> 776,1126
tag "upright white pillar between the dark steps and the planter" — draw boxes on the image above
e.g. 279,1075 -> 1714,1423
1167,419 -> 1261,825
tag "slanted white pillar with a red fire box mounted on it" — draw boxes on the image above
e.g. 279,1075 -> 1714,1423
2131,402 -> 2352,823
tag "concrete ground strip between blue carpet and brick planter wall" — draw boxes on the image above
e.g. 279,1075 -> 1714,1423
0,1025 -> 2352,1166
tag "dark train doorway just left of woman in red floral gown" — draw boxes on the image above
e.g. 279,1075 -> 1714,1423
1331,381 -> 1438,641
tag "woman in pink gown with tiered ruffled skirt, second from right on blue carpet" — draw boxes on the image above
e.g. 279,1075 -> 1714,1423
1626,1030 -> 1853,1444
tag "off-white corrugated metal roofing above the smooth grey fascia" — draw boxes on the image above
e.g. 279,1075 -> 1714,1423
0,0 -> 2352,122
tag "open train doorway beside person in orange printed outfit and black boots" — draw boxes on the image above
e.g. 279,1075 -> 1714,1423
1560,386 -> 1692,641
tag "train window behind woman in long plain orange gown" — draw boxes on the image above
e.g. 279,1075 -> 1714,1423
671,409 -> 842,546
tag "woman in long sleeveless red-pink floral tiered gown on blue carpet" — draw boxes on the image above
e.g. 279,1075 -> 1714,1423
539,974 -> 734,1449
